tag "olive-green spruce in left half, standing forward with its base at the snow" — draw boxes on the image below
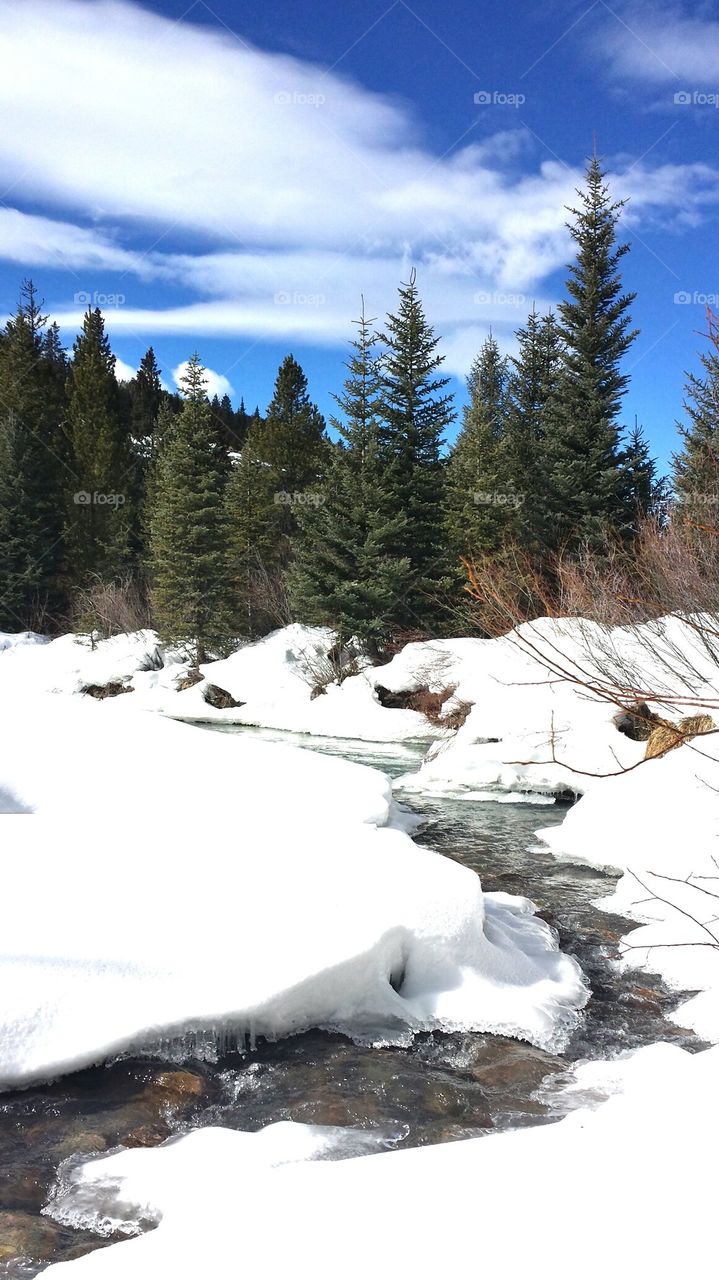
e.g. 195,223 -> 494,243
150,353 -> 232,663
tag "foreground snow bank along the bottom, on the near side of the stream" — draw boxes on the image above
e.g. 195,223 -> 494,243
43,1044 -> 719,1280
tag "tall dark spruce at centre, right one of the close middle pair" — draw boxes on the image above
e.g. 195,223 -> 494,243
379,270 -> 454,627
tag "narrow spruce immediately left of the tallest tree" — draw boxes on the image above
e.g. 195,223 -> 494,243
507,308 -> 562,552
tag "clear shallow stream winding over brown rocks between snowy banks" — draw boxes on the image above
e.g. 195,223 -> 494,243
0,730 -> 702,1280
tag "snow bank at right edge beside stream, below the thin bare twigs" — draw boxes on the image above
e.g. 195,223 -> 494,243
537,736 -> 719,1041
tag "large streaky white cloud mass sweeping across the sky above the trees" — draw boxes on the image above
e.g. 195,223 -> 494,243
0,0 -> 719,371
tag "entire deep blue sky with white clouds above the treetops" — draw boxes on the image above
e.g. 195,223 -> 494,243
0,0 -> 719,463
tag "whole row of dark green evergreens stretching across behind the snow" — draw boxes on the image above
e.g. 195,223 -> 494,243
0,157 -> 719,660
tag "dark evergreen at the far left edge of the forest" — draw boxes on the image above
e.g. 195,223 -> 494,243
0,288 -> 67,631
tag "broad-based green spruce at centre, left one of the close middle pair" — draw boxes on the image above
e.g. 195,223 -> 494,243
289,303 -> 411,652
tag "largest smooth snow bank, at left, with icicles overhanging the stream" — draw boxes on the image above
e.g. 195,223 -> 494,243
0,696 -> 586,1087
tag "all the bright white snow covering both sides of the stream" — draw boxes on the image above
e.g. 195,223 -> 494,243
0,620 -> 719,1280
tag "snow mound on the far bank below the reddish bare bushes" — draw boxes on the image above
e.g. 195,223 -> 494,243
388,618 -> 644,796
